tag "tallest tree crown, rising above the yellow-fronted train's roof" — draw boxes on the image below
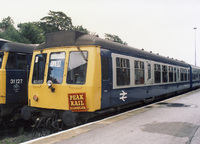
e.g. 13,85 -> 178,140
40,11 -> 73,33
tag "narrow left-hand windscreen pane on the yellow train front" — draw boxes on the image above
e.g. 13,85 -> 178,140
32,54 -> 47,84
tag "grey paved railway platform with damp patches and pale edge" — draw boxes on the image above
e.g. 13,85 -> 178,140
24,89 -> 200,144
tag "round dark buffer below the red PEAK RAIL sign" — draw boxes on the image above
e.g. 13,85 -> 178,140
62,111 -> 77,127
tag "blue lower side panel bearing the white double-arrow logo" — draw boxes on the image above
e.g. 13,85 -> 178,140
110,83 -> 190,106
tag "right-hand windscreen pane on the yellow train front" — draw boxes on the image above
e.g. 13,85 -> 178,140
67,51 -> 88,85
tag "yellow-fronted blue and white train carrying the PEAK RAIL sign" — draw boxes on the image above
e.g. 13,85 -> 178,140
21,31 -> 200,127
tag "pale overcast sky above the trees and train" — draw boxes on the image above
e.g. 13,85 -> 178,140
0,0 -> 200,66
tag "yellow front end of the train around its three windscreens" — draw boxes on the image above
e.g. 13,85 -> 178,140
28,46 -> 101,112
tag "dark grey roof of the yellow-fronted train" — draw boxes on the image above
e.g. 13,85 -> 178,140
36,31 -> 189,67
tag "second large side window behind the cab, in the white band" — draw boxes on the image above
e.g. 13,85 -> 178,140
135,61 -> 145,85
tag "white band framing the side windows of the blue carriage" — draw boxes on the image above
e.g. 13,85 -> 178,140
111,53 -> 190,89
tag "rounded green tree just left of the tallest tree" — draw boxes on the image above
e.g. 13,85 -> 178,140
18,22 -> 45,44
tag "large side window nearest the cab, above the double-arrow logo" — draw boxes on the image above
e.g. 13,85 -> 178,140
116,58 -> 130,86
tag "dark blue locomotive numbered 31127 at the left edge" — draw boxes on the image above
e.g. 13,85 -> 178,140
0,39 -> 35,123
